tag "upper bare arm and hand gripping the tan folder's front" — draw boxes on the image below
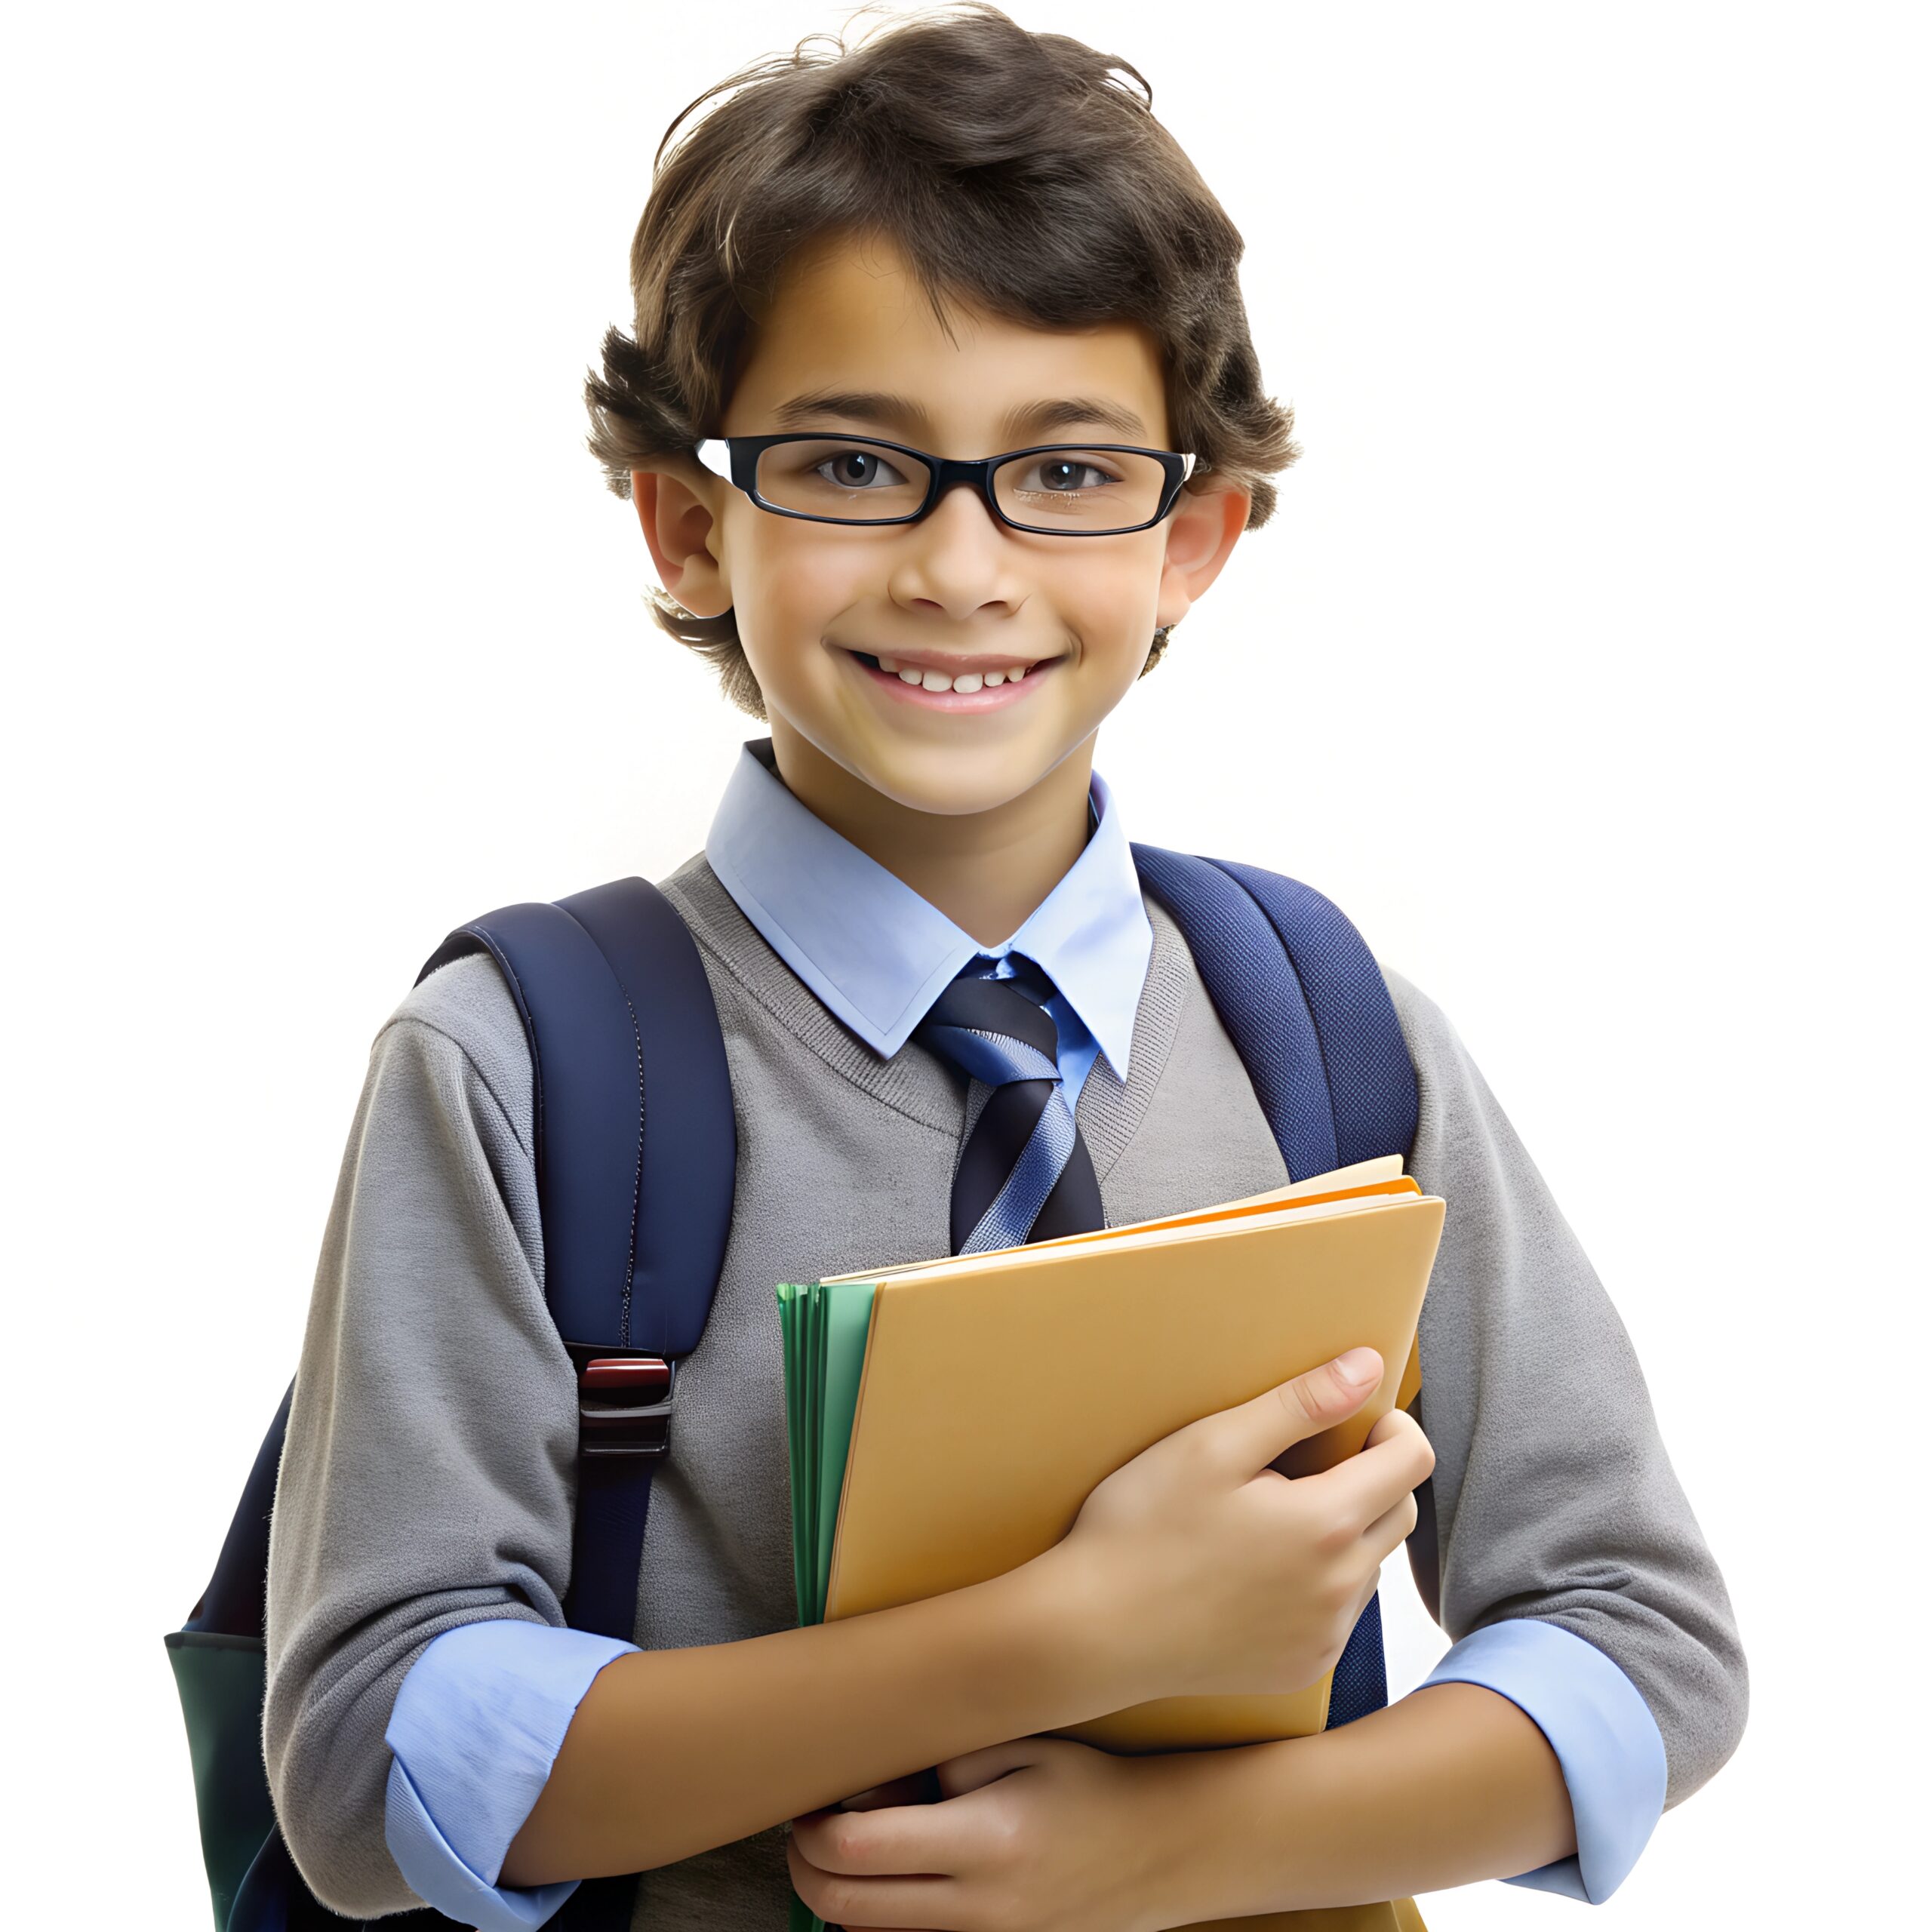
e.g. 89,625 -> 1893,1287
503,1350 -> 1429,1886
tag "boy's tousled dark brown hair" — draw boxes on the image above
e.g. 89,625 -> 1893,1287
586,0 -> 1298,717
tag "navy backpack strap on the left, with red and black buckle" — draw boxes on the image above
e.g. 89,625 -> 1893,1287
417,879 -> 738,1932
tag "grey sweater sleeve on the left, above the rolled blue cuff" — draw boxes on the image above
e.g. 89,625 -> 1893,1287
263,956 -> 577,1917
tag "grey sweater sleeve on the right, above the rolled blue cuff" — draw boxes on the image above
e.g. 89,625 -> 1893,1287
1386,972 -> 1746,1807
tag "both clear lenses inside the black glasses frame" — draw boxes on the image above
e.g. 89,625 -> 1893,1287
758,437 -> 1167,534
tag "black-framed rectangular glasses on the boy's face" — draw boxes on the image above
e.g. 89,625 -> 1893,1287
696,432 -> 1194,537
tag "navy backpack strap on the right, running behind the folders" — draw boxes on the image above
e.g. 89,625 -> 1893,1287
1134,844 -> 1420,1729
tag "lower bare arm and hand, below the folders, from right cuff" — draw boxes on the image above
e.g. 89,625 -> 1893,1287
790,1683 -> 1574,1932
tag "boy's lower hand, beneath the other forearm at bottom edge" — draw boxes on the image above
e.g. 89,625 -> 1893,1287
786,1737 -> 1169,1932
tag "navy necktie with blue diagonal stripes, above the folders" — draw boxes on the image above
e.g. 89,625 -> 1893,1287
915,955 -> 1107,1254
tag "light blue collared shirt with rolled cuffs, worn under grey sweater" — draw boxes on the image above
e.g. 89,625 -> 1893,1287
384,742 -> 1666,1932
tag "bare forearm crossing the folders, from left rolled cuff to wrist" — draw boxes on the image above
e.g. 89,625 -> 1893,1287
500,1552 -> 1134,1886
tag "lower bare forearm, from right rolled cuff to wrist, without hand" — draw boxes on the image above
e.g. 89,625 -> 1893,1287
1144,1684 -> 1577,1926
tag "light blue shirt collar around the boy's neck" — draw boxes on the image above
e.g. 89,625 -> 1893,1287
705,738 -> 1153,1080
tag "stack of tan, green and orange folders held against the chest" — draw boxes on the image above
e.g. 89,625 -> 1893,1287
777,1155 -> 1443,1932
